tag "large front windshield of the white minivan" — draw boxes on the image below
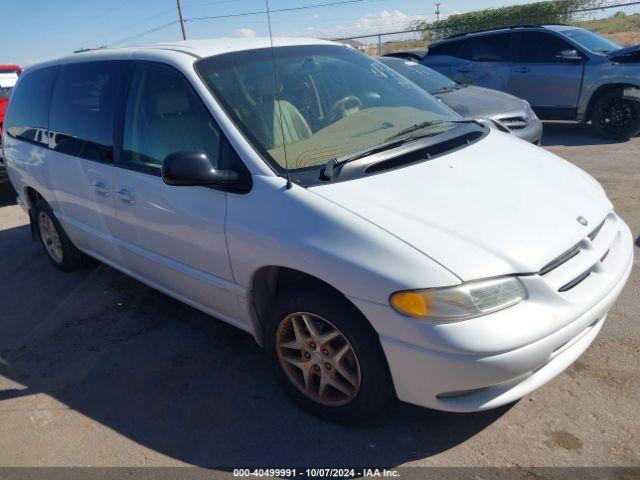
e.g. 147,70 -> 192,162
196,45 -> 460,173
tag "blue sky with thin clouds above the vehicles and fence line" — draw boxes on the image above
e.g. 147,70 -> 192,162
0,0 -> 528,66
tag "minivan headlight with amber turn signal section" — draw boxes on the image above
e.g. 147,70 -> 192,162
389,277 -> 527,322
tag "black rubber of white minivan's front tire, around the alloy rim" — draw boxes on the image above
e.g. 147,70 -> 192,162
264,289 -> 395,422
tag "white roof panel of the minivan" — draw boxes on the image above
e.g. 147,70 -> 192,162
29,37 -> 343,67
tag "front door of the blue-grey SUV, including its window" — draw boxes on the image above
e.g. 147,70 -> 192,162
507,32 -> 584,115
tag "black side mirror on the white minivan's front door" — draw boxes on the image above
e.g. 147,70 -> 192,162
162,152 -> 240,187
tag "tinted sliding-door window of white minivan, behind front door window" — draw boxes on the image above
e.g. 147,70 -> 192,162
50,61 -> 126,162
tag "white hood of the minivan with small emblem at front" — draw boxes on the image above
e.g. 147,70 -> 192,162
310,131 -> 612,281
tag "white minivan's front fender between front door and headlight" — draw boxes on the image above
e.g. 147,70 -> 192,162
227,176 -> 460,304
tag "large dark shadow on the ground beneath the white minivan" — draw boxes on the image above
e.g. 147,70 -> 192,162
0,223 -> 509,470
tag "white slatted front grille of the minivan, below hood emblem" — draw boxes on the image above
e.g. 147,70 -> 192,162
538,212 -> 620,293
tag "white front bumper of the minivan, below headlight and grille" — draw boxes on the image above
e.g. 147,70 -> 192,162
353,214 -> 633,412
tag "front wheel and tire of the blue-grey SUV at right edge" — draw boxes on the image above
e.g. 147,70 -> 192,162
591,89 -> 640,140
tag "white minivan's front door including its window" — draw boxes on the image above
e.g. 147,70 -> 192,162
114,62 -> 243,327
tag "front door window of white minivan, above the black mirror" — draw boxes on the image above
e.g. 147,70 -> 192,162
122,62 -> 221,174
